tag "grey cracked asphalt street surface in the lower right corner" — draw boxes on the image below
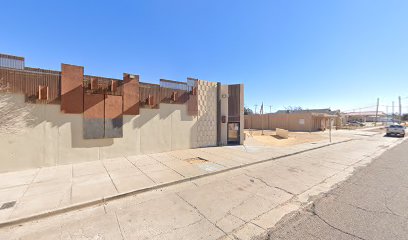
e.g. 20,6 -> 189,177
267,138 -> 408,240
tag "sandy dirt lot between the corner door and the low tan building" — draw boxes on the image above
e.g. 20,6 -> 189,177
244,130 -> 327,147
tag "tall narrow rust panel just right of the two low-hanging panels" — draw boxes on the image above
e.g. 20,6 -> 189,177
123,73 -> 139,115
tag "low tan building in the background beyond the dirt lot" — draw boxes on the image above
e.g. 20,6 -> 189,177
245,109 -> 342,132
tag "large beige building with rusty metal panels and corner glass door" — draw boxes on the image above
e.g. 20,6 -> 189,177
0,54 -> 244,172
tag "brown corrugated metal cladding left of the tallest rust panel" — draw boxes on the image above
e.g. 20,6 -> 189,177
0,68 -> 61,103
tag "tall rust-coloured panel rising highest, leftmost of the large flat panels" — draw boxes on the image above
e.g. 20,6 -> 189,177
61,64 -> 84,113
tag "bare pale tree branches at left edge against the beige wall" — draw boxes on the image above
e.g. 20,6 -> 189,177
0,79 -> 34,134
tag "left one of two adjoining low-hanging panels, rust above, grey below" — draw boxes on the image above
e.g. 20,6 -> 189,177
83,93 -> 105,139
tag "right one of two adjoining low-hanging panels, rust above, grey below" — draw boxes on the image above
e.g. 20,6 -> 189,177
105,95 -> 123,138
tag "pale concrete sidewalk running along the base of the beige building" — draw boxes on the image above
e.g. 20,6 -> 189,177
0,136 -> 349,225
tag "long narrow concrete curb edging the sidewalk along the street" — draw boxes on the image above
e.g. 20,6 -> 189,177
0,139 -> 353,228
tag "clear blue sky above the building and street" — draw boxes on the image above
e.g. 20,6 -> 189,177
0,0 -> 408,112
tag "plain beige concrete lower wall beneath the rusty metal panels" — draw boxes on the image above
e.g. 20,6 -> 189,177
0,94 -> 199,172
